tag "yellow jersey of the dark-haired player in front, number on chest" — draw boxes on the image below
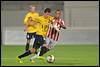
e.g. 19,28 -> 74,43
36,16 -> 53,37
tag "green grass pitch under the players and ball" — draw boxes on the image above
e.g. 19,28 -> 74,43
1,45 -> 99,66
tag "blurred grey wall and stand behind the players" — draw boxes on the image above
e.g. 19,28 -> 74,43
1,1 -> 99,45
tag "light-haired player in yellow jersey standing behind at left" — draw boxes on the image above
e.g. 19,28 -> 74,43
24,5 -> 39,51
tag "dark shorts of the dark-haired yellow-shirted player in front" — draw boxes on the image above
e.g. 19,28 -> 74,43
33,35 -> 45,49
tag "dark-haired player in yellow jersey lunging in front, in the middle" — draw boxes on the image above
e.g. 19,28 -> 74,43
17,8 -> 52,63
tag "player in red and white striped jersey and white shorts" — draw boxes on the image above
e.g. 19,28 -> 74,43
31,9 -> 66,60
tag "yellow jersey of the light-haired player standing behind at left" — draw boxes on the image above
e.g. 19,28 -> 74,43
24,12 -> 39,33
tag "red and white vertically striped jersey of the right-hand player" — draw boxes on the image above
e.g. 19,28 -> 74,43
47,18 -> 65,41
